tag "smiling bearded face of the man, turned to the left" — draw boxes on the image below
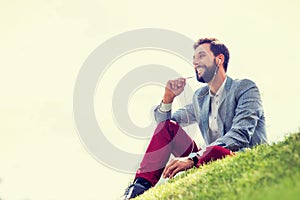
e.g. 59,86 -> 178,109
193,44 -> 217,83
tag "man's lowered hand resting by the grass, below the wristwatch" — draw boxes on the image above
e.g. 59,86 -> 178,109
163,157 -> 194,178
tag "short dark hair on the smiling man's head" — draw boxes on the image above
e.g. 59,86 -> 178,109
194,38 -> 229,72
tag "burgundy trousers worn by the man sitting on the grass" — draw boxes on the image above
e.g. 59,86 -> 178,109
135,120 -> 231,186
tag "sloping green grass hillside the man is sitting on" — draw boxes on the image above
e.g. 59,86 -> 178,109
136,133 -> 300,200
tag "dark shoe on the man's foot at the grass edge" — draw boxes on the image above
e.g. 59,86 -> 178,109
124,178 -> 151,200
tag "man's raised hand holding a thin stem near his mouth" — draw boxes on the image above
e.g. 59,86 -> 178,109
163,78 -> 186,103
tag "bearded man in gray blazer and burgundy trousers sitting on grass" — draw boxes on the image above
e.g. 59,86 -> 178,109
125,38 -> 267,199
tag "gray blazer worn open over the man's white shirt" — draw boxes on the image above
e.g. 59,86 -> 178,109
154,77 -> 267,151
